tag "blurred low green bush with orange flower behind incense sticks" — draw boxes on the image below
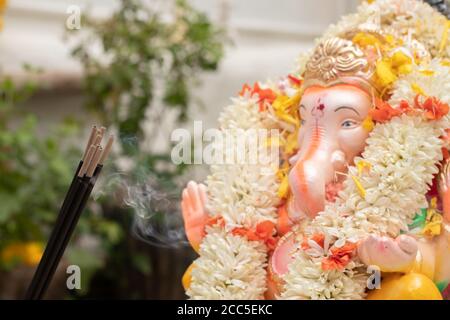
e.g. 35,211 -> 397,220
0,75 -> 122,288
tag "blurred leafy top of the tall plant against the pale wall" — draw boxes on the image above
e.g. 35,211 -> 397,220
73,0 -> 224,167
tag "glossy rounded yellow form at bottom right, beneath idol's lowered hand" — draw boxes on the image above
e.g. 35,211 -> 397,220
367,273 -> 442,300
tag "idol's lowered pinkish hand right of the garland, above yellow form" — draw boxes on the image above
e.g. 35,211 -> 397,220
358,235 -> 418,272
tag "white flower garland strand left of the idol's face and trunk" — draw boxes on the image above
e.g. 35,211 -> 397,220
186,90 -> 280,300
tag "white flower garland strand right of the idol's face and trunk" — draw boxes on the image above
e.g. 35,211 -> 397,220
281,55 -> 450,299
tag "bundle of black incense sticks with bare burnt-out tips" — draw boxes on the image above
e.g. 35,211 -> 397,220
25,126 -> 114,300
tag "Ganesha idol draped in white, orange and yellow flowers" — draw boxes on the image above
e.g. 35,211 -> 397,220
181,0 -> 450,299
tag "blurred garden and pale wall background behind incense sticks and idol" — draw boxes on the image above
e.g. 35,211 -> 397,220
0,0 -> 359,299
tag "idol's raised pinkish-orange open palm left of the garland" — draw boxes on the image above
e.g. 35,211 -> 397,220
181,181 -> 208,251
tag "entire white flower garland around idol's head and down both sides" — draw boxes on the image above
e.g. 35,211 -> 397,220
187,0 -> 450,299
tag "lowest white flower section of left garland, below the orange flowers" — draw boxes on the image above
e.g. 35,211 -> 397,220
186,227 -> 267,300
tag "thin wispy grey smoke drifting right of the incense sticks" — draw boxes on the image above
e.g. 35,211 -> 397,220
93,129 -> 195,248
